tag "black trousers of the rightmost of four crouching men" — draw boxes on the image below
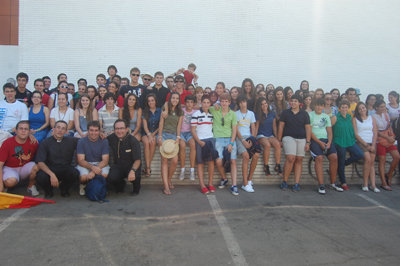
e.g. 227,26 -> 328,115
107,164 -> 142,194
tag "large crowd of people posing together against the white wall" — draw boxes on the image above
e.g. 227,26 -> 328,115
0,64 -> 400,199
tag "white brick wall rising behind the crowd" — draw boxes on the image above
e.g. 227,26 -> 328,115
1,0 -> 400,98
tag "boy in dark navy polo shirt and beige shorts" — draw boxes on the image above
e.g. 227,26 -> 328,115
278,95 -> 311,192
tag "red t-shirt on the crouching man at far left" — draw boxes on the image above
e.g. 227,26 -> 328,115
0,136 -> 39,168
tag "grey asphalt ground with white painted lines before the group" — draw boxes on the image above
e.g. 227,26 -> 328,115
0,185 -> 400,265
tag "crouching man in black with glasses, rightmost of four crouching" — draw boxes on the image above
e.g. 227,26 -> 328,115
107,119 -> 141,195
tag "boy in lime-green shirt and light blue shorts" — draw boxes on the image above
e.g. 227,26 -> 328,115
210,93 -> 239,196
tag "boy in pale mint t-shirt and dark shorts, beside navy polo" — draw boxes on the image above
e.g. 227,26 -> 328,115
309,98 -> 343,195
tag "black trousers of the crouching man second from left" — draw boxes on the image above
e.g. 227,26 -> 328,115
36,165 -> 79,194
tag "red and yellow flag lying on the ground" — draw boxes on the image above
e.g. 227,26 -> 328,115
0,192 -> 56,209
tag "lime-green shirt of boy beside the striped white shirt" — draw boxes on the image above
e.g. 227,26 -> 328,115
209,107 -> 237,138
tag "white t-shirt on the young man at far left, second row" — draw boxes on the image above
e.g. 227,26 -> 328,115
0,101 -> 29,131
